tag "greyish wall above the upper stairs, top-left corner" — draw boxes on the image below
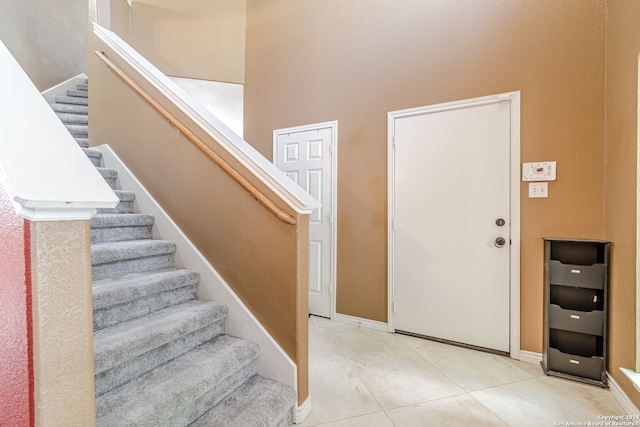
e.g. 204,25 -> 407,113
0,0 -> 88,91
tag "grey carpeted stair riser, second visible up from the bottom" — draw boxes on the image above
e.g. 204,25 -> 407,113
95,319 -> 224,397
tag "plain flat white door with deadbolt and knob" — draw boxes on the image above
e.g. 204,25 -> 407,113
391,97 -> 511,352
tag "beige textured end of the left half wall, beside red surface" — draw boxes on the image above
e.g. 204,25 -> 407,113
30,221 -> 95,426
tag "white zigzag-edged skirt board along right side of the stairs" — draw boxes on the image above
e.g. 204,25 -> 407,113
95,145 -> 298,390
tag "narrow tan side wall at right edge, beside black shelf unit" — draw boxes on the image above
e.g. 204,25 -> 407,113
604,0 -> 640,406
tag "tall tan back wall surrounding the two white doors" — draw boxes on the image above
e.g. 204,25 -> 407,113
245,0 -> 606,352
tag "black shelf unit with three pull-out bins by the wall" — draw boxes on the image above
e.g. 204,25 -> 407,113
542,238 -> 611,387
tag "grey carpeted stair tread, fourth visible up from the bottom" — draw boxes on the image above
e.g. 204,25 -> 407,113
93,268 -> 200,311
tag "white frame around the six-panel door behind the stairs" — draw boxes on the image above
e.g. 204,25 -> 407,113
271,120 -> 338,320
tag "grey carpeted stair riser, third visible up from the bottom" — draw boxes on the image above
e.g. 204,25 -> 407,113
93,284 -> 197,331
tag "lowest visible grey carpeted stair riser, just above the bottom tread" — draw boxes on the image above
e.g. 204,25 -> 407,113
156,361 -> 257,427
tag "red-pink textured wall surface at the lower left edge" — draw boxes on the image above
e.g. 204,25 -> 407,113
0,185 -> 34,426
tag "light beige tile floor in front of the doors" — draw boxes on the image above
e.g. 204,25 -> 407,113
302,316 -> 624,427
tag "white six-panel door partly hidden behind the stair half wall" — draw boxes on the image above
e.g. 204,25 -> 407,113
273,122 -> 337,318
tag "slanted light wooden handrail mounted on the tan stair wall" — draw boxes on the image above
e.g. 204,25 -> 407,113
94,50 -> 296,225
